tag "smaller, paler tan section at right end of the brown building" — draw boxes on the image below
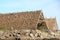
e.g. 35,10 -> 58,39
45,18 -> 58,31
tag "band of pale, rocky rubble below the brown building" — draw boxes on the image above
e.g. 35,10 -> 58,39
0,30 -> 60,40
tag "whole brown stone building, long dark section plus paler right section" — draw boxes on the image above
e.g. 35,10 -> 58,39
0,10 -> 57,31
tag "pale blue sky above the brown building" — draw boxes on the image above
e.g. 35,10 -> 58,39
0,0 -> 60,29
